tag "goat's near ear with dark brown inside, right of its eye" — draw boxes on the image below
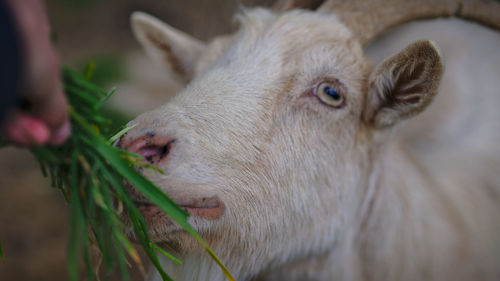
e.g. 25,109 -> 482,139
364,41 -> 444,128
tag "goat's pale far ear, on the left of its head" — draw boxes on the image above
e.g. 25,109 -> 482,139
131,12 -> 206,81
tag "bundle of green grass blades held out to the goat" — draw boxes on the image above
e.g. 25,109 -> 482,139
0,68 -> 234,281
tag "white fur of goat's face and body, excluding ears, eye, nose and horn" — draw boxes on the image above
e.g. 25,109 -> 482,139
127,9 -> 500,280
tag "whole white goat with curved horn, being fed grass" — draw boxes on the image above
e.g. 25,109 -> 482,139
120,0 -> 500,280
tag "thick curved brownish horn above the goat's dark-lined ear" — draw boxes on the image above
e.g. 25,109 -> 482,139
318,0 -> 500,46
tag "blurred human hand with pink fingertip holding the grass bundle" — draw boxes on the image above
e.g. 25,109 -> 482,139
4,0 -> 71,144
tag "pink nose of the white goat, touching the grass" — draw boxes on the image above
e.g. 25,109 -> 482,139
118,132 -> 175,164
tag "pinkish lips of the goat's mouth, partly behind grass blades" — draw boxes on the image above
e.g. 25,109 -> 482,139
135,196 -> 225,223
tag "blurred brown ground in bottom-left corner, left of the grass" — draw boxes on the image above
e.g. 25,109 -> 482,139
0,149 -> 68,280
